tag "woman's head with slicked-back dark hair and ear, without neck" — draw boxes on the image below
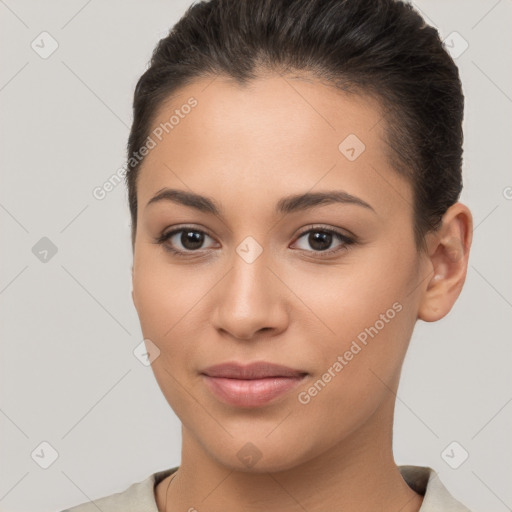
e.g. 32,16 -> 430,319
126,0 -> 472,471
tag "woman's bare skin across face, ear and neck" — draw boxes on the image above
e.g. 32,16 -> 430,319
133,75 -> 472,512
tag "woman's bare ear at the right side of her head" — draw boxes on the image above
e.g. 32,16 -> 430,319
418,203 -> 473,322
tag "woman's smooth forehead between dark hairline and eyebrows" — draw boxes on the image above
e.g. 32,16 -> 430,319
138,75 -> 412,219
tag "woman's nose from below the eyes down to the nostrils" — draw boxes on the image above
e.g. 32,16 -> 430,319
212,247 -> 291,340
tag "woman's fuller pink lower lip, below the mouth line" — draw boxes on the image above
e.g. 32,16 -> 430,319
203,375 -> 304,407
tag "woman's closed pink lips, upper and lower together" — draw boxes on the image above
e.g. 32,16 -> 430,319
201,362 -> 307,407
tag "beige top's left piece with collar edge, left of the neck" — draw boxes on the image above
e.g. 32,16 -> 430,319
61,468 -> 177,512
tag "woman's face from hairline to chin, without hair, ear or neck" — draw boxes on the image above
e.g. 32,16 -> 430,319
133,76 -> 424,471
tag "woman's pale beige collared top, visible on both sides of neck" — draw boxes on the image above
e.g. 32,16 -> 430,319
62,466 -> 471,512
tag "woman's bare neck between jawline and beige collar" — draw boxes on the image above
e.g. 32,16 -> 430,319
157,396 -> 422,512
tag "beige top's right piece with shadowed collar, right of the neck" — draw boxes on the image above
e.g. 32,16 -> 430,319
398,466 -> 471,512
